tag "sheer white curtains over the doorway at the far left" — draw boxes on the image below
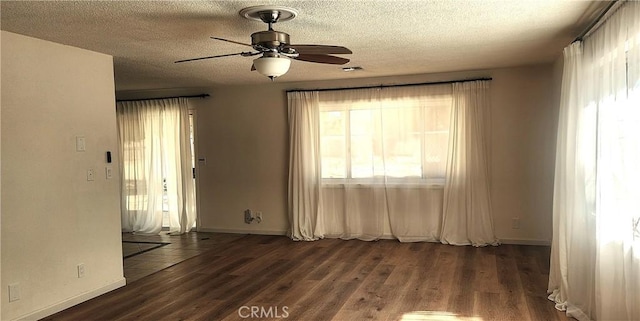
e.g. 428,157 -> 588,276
117,98 -> 196,234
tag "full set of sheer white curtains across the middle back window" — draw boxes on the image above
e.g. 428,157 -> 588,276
288,83 -> 496,245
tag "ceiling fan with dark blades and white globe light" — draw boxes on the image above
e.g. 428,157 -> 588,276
175,6 -> 352,80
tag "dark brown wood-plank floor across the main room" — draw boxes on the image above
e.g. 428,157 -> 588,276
45,233 -> 573,321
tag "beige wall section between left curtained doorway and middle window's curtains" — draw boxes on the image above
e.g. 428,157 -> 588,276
193,84 -> 289,234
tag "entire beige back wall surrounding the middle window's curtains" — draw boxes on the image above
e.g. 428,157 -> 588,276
192,64 -> 557,244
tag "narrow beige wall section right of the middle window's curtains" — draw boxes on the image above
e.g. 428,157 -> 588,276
491,65 -> 558,244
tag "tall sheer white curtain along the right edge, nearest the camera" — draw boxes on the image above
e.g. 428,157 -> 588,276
549,2 -> 640,320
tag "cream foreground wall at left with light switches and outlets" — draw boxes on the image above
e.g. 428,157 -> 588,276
0,31 -> 124,320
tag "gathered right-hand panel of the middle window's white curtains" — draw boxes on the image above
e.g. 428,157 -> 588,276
442,81 -> 498,246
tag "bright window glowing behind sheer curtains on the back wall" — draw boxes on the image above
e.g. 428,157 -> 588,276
320,88 -> 452,184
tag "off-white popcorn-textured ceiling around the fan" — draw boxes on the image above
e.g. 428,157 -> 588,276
0,0 -> 607,91
